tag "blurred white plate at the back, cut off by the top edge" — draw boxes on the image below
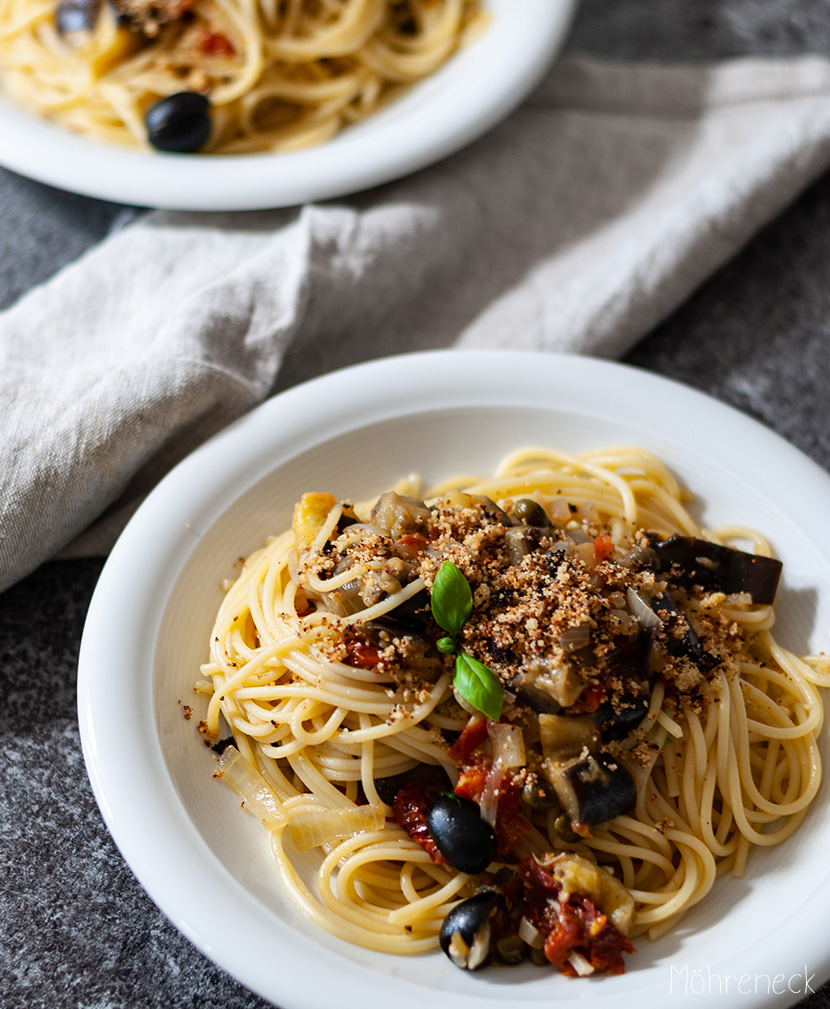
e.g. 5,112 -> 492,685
0,0 -> 576,210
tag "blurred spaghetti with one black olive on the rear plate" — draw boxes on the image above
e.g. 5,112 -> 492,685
0,0 -> 483,153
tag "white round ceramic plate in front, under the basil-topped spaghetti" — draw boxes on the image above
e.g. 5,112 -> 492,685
79,351 -> 830,1009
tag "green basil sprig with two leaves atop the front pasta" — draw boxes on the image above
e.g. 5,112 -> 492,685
430,561 -> 504,721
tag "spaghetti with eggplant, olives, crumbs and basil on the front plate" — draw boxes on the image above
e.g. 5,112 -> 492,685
197,448 -> 830,975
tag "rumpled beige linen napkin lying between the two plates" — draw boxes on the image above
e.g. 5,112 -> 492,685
0,58 -> 830,588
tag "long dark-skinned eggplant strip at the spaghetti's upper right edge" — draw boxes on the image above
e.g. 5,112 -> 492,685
649,534 -> 782,604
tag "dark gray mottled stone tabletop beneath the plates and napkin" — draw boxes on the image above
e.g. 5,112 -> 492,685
0,0 -> 830,1009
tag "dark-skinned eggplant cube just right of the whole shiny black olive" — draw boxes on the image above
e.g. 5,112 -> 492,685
548,753 -> 637,825
